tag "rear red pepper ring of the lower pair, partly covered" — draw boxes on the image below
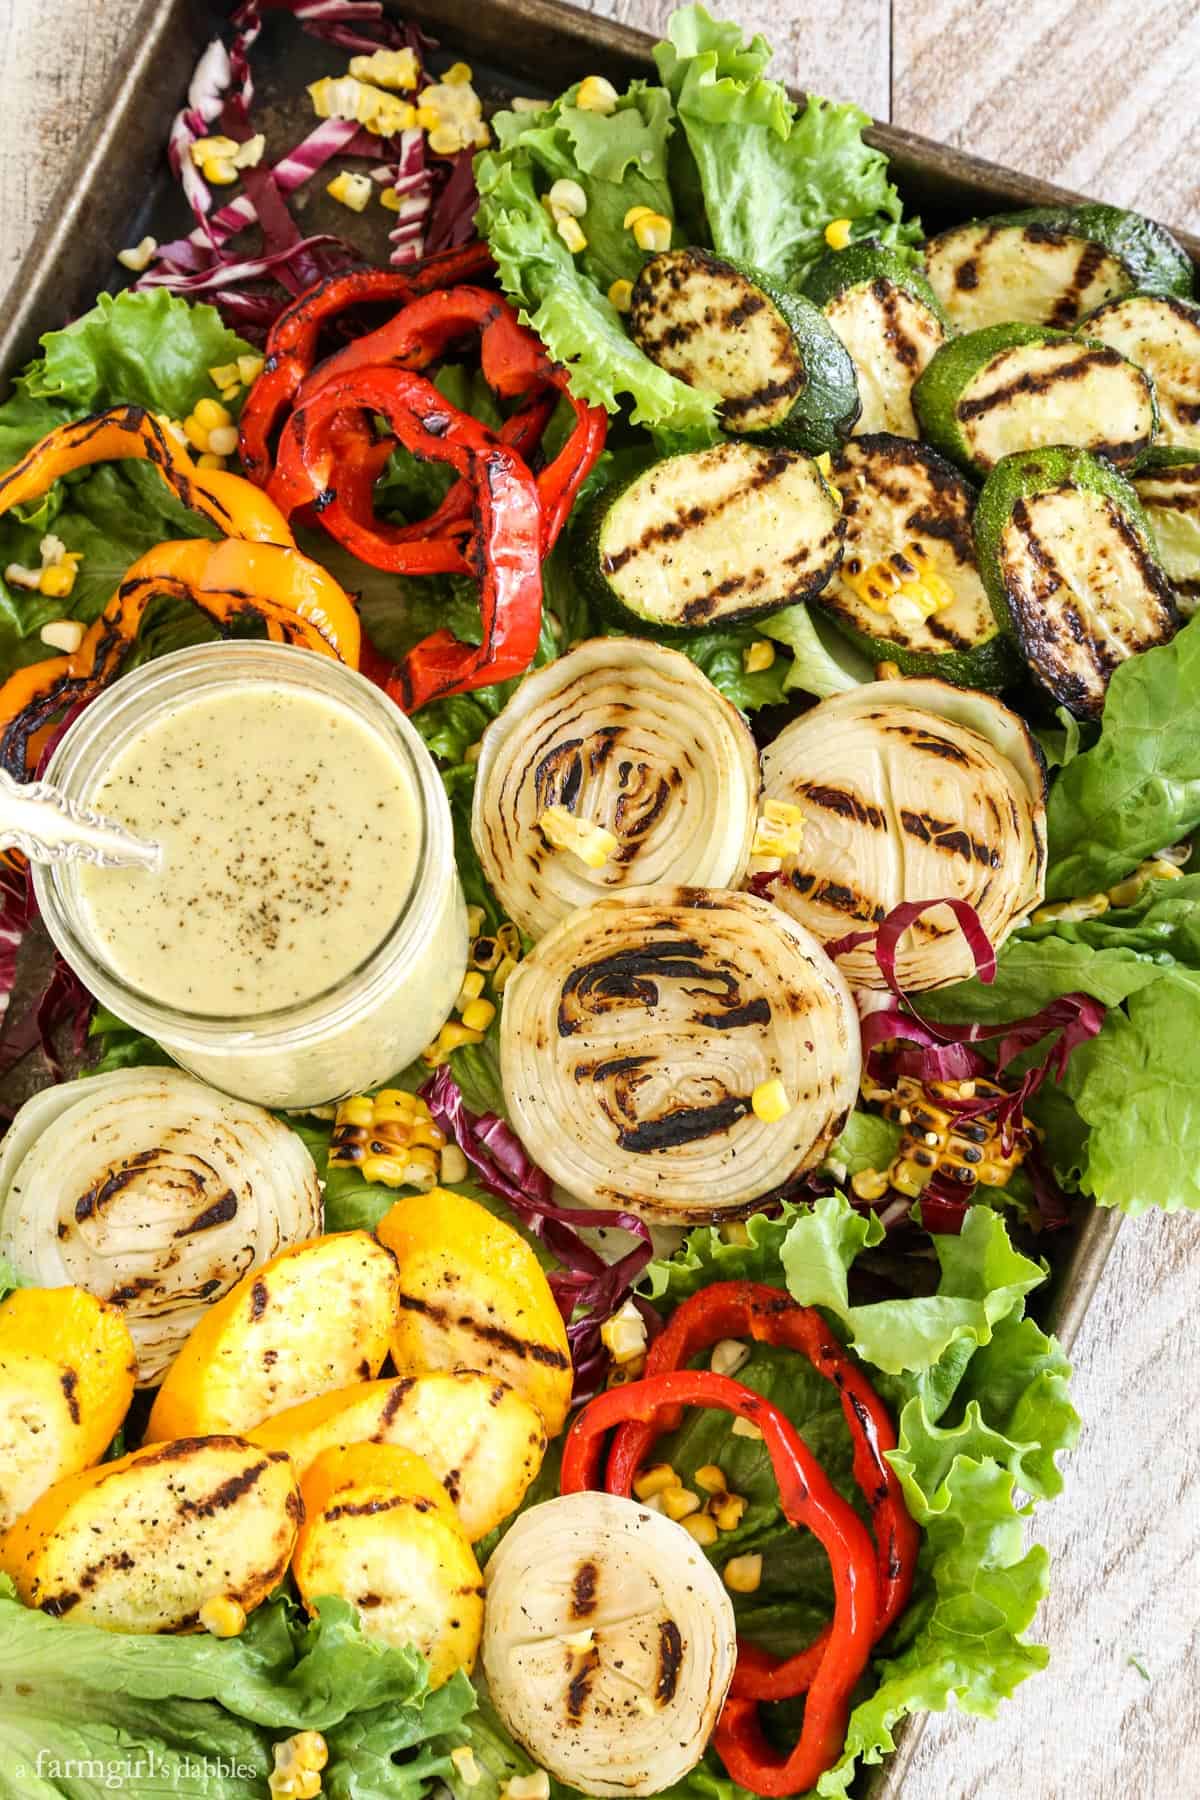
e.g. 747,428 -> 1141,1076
608,1282 -> 921,1699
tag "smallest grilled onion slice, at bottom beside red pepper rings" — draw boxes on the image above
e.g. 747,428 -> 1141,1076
482,1494 -> 738,1795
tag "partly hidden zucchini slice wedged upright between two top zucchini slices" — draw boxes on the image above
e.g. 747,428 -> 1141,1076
804,243 -> 952,437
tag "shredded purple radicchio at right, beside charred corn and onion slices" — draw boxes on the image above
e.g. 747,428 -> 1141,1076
826,900 -> 1105,1231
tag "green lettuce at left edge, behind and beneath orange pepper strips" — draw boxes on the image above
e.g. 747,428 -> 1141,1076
0,290 -> 250,675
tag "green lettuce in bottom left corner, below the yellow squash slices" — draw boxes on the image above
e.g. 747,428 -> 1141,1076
0,1577 -> 475,1800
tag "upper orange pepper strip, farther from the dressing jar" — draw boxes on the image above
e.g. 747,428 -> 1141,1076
0,407 -> 295,545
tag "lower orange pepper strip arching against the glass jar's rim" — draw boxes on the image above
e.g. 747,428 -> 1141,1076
0,538 -> 362,781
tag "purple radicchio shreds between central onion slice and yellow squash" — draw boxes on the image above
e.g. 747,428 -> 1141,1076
421,1064 -> 658,1400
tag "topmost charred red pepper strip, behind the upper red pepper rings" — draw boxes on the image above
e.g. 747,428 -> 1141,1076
237,241 -> 491,488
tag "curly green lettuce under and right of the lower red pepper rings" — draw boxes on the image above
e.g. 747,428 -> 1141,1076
629,1195 -> 1079,1800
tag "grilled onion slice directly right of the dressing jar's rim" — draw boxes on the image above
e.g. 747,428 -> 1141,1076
471,637 -> 759,938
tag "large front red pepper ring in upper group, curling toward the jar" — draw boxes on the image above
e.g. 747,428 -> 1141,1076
270,369 -> 542,711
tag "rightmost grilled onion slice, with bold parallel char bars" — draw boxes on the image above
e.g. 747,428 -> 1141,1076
763,680 -> 1045,990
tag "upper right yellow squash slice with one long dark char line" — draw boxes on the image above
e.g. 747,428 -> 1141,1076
376,1188 -> 572,1436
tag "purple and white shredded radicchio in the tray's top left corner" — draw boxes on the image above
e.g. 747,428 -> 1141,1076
137,0 -> 477,342
